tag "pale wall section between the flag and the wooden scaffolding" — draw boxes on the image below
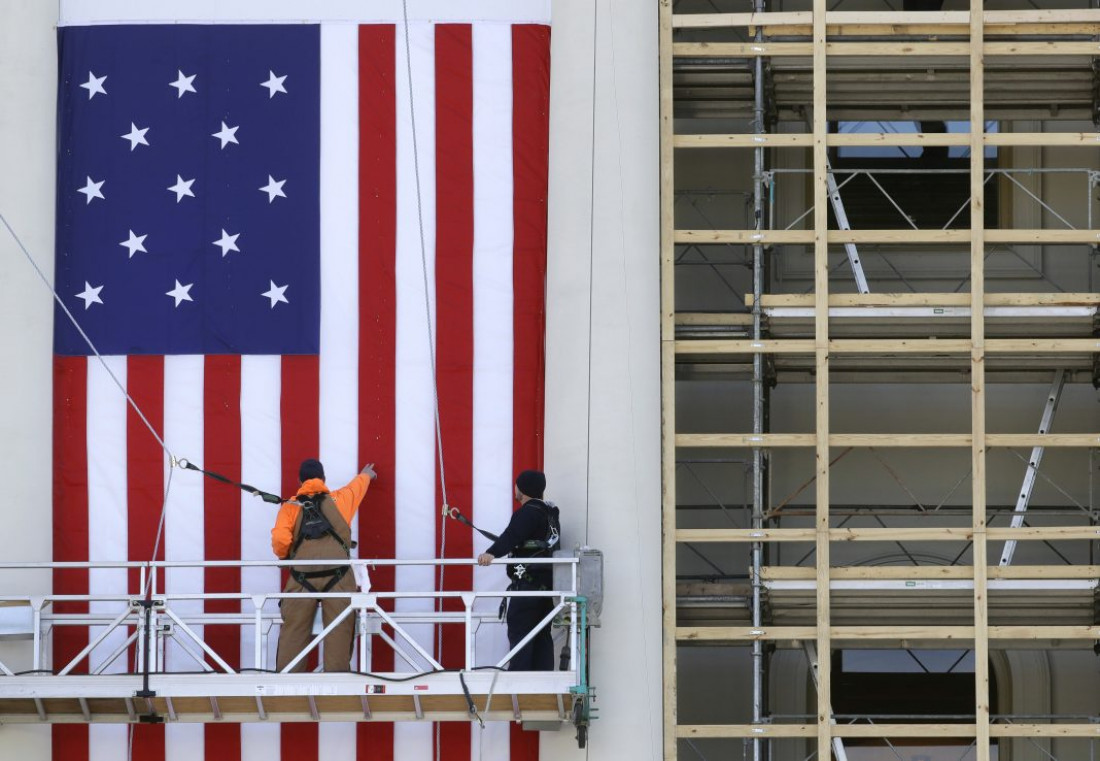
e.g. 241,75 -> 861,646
542,0 -> 662,761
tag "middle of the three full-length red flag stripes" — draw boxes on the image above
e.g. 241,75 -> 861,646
436,24 -> 474,761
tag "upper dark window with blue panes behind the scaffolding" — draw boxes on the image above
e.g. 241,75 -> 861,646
829,121 -> 999,230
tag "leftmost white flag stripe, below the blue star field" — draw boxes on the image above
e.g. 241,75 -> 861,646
87,356 -> 128,761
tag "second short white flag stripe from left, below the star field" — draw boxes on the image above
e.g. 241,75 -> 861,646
163,356 -> 205,761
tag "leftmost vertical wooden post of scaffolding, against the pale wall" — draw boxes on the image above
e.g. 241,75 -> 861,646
660,0 -> 677,761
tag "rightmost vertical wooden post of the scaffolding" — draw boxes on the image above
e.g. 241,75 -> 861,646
970,5 -> 989,761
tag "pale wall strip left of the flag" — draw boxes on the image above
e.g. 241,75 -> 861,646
0,0 -> 57,761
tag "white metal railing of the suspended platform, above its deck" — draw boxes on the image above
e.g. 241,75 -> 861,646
0,558 -> 585,684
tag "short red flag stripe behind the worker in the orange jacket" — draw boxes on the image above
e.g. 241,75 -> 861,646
281,355 -> 321,761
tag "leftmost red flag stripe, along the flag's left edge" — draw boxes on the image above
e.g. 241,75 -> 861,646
51,356 -> 88,761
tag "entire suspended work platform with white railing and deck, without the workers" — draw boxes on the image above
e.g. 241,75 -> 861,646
0,551 -> 601,740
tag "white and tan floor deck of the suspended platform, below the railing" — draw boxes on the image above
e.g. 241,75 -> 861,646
0,671 -> 576,724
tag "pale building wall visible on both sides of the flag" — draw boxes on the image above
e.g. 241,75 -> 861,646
0,0 -> 662,761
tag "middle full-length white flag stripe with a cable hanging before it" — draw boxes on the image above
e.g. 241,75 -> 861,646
394,16 -> 433,761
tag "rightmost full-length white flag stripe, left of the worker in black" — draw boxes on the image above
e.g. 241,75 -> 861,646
471,25 -> 513,759
